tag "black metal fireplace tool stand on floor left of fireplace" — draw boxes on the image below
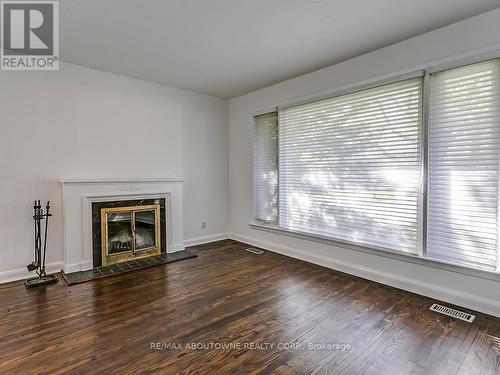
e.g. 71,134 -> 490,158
24,200 -> 59,288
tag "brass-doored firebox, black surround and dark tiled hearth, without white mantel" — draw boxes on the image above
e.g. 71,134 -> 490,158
61,189 -> 196,285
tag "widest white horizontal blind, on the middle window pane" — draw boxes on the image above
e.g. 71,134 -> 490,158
279,78 -> 422,253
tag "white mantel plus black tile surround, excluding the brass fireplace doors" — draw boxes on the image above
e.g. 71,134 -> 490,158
61,178 -> 184,273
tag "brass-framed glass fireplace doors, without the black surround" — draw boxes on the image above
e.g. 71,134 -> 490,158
101,204 -> 161,266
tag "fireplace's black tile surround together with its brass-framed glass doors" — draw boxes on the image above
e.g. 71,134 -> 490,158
92,198 -> 166,267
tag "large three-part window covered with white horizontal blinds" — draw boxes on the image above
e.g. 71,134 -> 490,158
254,60 -> 500,270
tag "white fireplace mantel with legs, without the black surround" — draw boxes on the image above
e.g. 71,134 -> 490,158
61,178 -> 184,272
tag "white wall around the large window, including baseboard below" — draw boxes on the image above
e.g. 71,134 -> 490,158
229,10 -> 500,316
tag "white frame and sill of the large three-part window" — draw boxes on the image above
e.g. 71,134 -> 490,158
249,50 -> 500,281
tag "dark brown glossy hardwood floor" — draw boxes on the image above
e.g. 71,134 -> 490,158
0,241 -> 500,375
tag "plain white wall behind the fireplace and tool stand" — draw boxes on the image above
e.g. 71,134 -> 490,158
0,64 -> 229,280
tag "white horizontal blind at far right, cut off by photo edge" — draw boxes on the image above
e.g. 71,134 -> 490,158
427,60 -> 500,270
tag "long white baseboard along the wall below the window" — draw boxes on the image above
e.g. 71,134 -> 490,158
229,233 -> 500,317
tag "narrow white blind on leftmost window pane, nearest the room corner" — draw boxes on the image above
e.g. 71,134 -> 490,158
253,113 -> 278,222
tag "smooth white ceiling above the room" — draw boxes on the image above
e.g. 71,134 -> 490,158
59,0 -> 500,98
